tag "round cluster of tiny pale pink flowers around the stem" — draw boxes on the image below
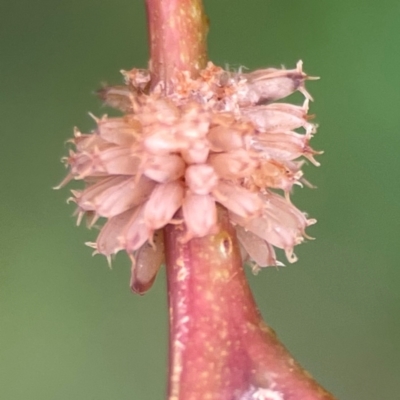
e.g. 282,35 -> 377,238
60,62 -> 318,290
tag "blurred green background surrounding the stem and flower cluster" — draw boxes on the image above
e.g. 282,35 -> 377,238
0,0 -> 400,400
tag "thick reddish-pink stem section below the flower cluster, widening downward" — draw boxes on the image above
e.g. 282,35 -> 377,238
166,210 -> 333,400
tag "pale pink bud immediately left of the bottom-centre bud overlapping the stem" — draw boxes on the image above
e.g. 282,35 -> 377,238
144,181 -> 184,230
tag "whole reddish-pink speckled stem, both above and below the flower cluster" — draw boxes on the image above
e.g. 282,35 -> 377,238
146,0 -> 333,400
